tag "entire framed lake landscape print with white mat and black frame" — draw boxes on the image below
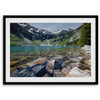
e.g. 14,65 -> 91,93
3,15 -> 98,85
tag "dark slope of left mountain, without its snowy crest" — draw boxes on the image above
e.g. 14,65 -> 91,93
10,23 -> 56,41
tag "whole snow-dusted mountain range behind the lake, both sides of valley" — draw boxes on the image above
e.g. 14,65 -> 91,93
10,23 -> 81,46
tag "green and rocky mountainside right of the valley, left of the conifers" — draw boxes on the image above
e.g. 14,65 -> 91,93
50,27 -> 81,46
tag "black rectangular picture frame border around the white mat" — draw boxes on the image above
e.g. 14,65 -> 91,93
3,15 -> 98,85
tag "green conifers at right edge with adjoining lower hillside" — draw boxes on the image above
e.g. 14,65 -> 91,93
63,23 -> 91,46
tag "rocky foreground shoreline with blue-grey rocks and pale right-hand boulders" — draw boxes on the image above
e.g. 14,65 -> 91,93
10,45 -> 91,77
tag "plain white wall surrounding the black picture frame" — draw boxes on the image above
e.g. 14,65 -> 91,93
0,0 -> 100,100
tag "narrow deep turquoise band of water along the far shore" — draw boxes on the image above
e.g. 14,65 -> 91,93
10,46 -> 79,53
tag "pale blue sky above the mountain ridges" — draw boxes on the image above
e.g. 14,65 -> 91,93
29,23 -> 82,32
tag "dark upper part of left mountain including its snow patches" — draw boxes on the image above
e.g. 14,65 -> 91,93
10,23 -> 54,41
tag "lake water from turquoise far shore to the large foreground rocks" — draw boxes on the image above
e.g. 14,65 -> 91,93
10,46 -> 80,73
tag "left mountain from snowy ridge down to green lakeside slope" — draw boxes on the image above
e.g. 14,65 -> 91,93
10,23 -> 56,45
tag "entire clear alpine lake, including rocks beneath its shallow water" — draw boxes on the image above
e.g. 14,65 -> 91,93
10,46 -> 91,77
